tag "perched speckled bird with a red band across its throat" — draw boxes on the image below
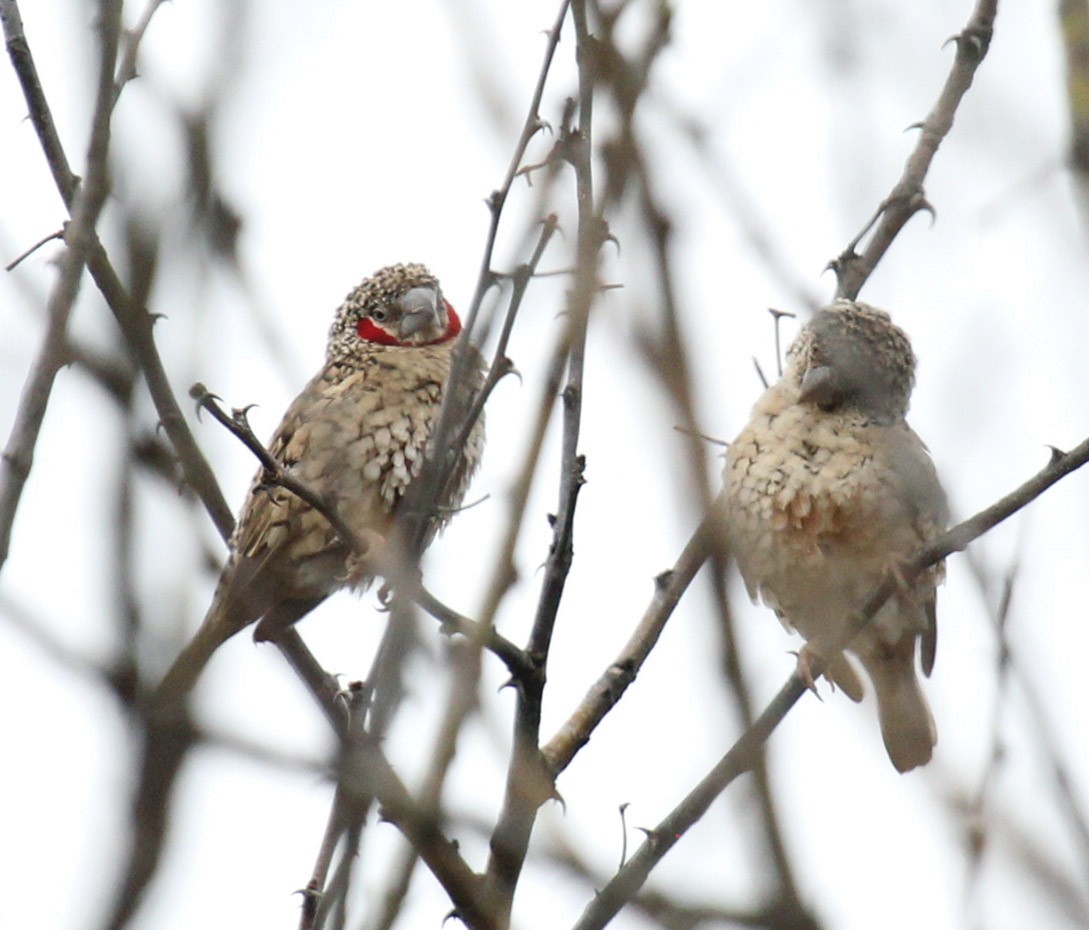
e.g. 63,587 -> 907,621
151,265 -> 485,708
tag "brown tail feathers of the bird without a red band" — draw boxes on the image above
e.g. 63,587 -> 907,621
865,657 -> 938,772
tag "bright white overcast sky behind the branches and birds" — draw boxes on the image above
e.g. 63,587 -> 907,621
0,0 -> 1089,930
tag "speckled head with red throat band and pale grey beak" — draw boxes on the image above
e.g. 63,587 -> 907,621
329,265 -> 462,359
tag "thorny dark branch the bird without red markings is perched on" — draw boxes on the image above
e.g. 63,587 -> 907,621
575,439 -> 1089,930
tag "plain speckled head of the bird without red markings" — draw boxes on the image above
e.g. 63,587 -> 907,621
787,301 -> 915,420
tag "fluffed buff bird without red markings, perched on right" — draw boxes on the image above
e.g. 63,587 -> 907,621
722,301 -> 949,772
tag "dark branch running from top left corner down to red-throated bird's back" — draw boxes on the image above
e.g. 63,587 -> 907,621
0,0 -> 234,539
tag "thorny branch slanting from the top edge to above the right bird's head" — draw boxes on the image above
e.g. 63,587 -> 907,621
829,0 -> 999,299
